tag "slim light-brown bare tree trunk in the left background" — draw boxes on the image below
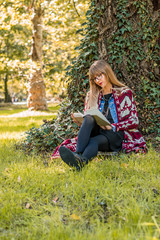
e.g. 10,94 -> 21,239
27,7 -> 47,110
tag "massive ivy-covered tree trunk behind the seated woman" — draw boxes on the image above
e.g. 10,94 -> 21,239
22,0 -> 160,153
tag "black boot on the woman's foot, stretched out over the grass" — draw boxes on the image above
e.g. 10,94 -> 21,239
59,146 -> 88,170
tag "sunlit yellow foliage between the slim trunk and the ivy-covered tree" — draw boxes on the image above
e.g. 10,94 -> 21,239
43,0 -> 88,98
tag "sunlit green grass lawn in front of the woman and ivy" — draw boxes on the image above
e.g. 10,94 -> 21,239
0,106 -> 160,240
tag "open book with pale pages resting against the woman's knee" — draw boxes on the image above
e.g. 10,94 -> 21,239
73,108 -> 111,126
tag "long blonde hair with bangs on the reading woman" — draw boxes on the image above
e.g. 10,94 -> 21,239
87,60 -> 126,108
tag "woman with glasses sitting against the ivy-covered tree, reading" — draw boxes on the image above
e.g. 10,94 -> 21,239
54,60 -> 146,170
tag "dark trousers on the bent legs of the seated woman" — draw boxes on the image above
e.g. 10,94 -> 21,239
76,115 -> 124,160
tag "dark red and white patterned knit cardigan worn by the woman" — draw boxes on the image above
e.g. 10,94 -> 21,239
52,88 -> 146,158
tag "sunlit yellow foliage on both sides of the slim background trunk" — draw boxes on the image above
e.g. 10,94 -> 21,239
0,0 -> 88,103
